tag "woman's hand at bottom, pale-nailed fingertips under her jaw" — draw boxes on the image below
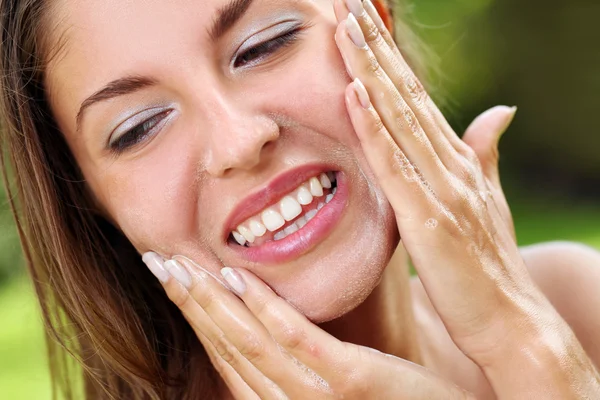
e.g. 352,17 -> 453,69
144,253 -> 473,400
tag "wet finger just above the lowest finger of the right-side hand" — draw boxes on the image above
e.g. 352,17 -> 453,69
336,10 -> 447,188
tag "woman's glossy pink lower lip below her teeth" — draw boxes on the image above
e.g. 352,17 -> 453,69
230,170 -> 348,264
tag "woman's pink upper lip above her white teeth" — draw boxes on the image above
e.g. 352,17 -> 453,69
223,164 -> 336,241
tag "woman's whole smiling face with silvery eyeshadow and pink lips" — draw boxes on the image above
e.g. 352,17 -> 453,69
47,0 -> 397,322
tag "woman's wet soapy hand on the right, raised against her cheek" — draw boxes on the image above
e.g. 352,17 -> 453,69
335,0 -> 600,398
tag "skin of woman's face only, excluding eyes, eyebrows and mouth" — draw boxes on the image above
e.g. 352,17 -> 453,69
48,0 -> 397,321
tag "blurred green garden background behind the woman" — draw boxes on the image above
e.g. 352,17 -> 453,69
0,0 -> 600,400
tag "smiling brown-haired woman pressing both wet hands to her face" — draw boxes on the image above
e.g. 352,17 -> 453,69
1,0 -> 600,399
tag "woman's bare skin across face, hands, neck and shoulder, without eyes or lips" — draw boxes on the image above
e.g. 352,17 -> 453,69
48,0 -> 600,399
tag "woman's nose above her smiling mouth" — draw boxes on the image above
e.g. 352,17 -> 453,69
205,98 -> 279,177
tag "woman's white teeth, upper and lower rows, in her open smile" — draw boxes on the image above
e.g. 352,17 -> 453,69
232,172 -> 335,246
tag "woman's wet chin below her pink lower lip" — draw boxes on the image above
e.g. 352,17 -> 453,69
271,188 -> 400,324
